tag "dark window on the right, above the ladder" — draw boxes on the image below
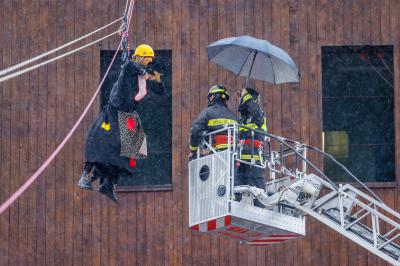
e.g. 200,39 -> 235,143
321,46 -> 395,182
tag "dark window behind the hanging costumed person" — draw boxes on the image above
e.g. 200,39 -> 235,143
100,50 -> 172,187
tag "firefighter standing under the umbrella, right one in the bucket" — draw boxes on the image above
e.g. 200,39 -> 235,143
235,88 -> 267,208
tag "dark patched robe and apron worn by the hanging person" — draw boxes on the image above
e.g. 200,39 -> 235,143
85,60 -> 146,171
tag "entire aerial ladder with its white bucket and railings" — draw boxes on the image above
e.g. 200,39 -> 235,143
189,126 -> 400,265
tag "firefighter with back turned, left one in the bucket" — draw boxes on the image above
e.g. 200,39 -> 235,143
189,85 -> 237,160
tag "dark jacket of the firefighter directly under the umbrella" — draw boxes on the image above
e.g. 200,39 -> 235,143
238,93 -> 267,161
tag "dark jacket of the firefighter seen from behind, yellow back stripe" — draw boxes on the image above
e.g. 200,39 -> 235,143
189,101 -> 237,151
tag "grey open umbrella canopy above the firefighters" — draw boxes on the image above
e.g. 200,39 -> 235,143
207,36 -> 299,84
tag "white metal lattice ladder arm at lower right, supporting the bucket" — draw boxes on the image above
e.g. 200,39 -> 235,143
274,174 -> 400,265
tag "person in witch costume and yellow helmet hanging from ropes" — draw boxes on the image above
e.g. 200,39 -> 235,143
78,44 -> 160,202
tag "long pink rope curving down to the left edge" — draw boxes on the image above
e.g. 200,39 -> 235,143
0,1 -> 135,214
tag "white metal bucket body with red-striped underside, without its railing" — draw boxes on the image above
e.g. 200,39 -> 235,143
189,150 -> 305,246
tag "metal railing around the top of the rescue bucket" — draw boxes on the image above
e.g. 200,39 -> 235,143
197,124 -> 382,202
